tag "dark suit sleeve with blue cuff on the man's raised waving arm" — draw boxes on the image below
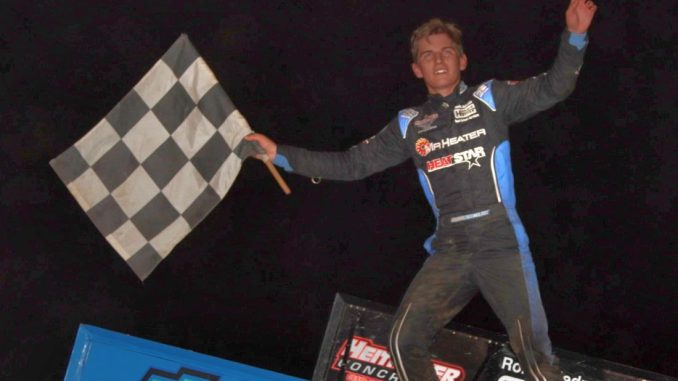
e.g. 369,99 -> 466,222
489,31 -> 588,125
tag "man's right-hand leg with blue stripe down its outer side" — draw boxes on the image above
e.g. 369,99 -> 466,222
473,251 -> 560,381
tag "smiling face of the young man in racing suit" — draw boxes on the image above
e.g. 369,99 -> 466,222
412,33 -> 468,96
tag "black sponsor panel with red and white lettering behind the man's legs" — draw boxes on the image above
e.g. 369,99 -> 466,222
312,294 -> 678,381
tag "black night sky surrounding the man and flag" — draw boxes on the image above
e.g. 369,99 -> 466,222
0,0 -> 678,380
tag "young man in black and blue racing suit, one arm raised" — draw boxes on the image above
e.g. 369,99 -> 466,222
247,0 -> 597,381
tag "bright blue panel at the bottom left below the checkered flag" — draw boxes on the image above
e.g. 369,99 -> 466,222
64,324 -> 303,381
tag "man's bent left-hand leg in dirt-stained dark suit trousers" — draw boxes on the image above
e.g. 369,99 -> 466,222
389,253 -> 477,381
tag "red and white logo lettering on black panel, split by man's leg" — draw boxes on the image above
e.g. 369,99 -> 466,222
331,336 -> 466,381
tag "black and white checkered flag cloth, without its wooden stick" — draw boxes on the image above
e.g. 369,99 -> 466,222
50,35 -> 259,280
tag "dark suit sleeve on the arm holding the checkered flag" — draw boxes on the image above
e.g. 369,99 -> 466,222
273,119 -> 409,181
